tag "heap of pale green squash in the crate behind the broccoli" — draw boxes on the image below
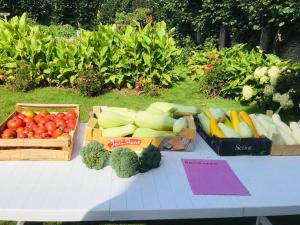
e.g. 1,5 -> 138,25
97,102 -> 197,138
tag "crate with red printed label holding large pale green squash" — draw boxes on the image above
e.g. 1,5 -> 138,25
85,106 -> 196,151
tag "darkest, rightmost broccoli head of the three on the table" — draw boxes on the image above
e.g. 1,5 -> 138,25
139,144 -> 161,173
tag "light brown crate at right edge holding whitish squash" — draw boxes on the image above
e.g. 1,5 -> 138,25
266,110 -> 300,156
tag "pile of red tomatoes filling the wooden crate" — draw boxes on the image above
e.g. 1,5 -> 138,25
1,109 -> 77,139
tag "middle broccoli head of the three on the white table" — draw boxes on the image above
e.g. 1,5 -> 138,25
110,148 -> 139,178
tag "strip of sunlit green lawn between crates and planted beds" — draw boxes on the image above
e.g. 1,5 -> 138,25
0,81 -> 255,122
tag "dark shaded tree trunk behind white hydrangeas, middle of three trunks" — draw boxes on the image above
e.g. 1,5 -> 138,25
259,25 -> 276,53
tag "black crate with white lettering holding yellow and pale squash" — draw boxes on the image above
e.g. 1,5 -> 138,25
196,118 -> 272,156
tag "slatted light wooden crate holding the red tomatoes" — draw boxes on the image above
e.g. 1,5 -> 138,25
0,103 -> 80,160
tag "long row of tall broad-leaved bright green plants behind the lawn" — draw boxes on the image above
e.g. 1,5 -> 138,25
0,14 -> 180,91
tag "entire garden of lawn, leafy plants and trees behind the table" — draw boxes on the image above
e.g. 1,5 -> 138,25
0,0 -> 300,121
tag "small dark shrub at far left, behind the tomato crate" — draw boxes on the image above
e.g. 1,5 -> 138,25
6,61 -> 36,92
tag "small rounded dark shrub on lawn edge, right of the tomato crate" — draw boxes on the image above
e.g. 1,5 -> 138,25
75,69 -> 104,97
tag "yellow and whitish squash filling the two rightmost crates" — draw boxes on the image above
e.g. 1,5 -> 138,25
198,108 -> 300,145
